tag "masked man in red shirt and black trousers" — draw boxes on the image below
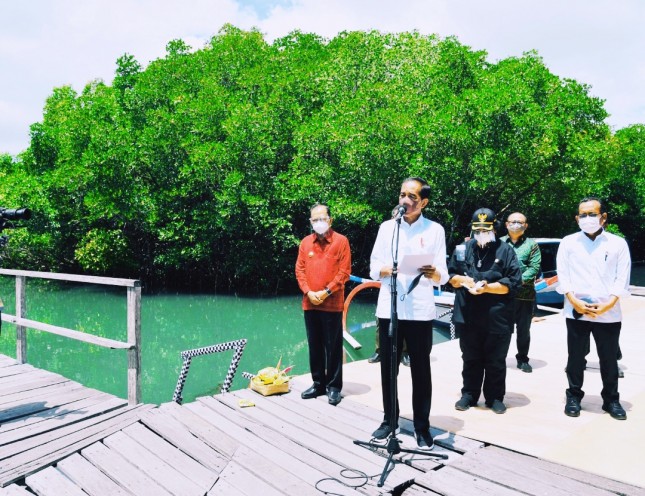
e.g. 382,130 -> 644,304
296,204 -> 352,405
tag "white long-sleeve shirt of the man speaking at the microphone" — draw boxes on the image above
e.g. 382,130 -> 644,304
370,216 -> 448,320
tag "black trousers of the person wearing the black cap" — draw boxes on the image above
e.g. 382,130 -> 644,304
455,324 -> 511,405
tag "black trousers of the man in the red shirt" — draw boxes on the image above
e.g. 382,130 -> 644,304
305,310 -> 343,391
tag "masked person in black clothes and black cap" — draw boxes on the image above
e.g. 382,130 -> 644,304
448,208 -> 522,413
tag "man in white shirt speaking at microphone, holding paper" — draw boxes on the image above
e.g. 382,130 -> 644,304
370,177 -> 448,449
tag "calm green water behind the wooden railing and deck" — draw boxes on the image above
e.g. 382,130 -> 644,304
0,276 -> 452,403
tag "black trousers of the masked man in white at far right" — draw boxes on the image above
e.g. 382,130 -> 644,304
566,319 -> 622,403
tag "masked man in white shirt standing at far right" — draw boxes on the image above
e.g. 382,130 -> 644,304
557,197 -> 631,420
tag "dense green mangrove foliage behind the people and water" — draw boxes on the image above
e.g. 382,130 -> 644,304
0,26 -> 645,292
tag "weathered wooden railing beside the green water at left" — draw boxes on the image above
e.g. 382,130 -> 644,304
0,269 -> 141,405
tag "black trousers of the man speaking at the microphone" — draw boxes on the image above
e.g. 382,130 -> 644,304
378,319 -> 432,432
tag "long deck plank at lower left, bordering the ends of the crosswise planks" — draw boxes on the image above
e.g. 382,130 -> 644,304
0,405 -> 151,486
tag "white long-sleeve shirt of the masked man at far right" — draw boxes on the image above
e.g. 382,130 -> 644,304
556,231 -> 631,322
